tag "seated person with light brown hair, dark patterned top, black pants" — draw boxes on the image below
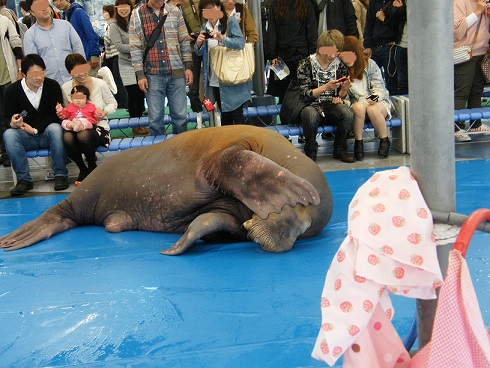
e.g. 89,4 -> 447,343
297,30 -> 354,163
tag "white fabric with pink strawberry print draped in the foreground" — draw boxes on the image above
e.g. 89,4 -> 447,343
312,167 -> 442,368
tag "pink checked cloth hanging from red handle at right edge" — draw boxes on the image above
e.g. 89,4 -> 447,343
410,250 -> 490,368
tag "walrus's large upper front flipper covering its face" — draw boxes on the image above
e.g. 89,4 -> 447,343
203,147 -> 320,219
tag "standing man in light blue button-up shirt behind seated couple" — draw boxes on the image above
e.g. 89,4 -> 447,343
24,0 -> 85,86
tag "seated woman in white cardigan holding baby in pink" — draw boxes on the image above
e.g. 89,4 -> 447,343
57,54 -> 117,182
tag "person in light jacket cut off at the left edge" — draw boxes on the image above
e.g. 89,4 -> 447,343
0,15 -> 24,167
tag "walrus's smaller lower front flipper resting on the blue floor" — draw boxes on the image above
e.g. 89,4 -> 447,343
160,212 -> 241,256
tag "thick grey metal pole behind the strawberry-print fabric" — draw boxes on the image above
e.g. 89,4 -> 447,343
407,0 -> 456,348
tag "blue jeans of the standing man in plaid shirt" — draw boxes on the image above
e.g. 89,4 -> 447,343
146,74 -> 187,135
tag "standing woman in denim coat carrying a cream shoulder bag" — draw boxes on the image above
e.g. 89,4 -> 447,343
194,0 -> 252,125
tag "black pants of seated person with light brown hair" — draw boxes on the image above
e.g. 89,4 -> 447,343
301,104 -> 354,155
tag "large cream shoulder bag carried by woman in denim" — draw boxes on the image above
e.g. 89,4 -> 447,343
209,43 -> 255,86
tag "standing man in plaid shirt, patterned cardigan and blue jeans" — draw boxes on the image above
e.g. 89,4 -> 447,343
129,0 -> 192,135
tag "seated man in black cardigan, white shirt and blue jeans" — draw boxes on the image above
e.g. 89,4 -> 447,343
2,54 -> 68,196
